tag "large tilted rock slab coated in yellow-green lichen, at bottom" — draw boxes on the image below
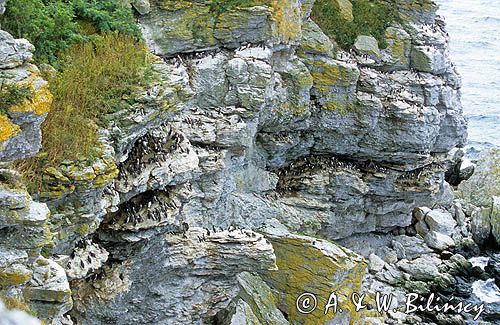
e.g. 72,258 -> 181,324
267,235 -> 366,325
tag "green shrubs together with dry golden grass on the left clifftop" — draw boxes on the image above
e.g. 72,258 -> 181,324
0,0 -> 149,191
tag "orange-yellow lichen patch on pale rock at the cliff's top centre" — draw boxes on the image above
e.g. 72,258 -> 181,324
273,0 -> 302,43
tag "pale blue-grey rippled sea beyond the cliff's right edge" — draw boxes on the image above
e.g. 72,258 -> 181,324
436,0 -> 500,147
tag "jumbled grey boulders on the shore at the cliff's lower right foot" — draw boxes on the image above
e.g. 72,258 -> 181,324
339,192 -> 499,324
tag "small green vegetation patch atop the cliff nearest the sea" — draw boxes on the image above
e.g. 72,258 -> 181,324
311,0 -> 397,48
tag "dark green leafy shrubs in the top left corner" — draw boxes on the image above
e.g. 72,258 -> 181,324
0,0 -> 140,63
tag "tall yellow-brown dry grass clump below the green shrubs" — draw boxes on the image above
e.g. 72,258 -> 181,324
17,32 -> 149,191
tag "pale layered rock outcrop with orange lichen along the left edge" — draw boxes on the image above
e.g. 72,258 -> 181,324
0,22 -> 73,324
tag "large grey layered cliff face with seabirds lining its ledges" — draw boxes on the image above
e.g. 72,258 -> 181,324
0,0 -> 474,324
